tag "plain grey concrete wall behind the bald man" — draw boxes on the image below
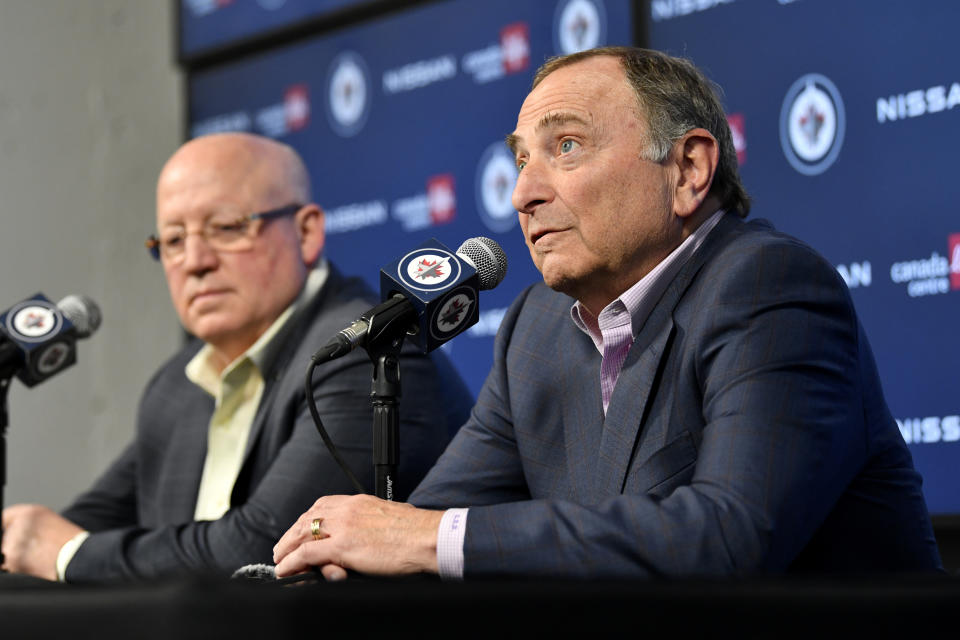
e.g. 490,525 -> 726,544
0,0 -> 183,508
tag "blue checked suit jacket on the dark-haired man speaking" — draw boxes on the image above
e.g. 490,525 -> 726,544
410,215 -> 940,577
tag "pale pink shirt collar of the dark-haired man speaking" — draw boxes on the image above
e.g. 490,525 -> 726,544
570,209 -> 725,353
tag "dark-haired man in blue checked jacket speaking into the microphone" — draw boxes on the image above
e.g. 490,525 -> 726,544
274,48 -> 940,579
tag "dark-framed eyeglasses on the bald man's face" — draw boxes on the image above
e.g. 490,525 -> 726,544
144,204 -> 303,262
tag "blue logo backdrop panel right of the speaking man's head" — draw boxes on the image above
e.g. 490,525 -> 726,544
647,0 -> 960,514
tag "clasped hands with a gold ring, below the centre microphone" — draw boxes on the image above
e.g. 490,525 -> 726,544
273,495 -> 443,580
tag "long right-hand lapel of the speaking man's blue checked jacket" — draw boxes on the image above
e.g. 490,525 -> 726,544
595,215 -> 740,496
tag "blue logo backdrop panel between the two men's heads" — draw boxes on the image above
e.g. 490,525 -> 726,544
189,0 -> 633,393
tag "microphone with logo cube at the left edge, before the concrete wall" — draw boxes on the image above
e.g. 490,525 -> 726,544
0,293 -> 101,387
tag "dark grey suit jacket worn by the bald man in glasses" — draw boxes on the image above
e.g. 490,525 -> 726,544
63,268 -> 472,582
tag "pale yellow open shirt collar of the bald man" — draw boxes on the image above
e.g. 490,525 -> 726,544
184,257 -> 330,396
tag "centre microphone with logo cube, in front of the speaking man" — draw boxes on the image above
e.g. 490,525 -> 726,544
313,237 -> 507,362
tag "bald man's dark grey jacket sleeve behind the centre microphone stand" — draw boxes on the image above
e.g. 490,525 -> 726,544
60,340 -> 465,582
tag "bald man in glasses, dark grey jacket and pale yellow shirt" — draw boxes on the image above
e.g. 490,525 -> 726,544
3,134 -> 472,582
